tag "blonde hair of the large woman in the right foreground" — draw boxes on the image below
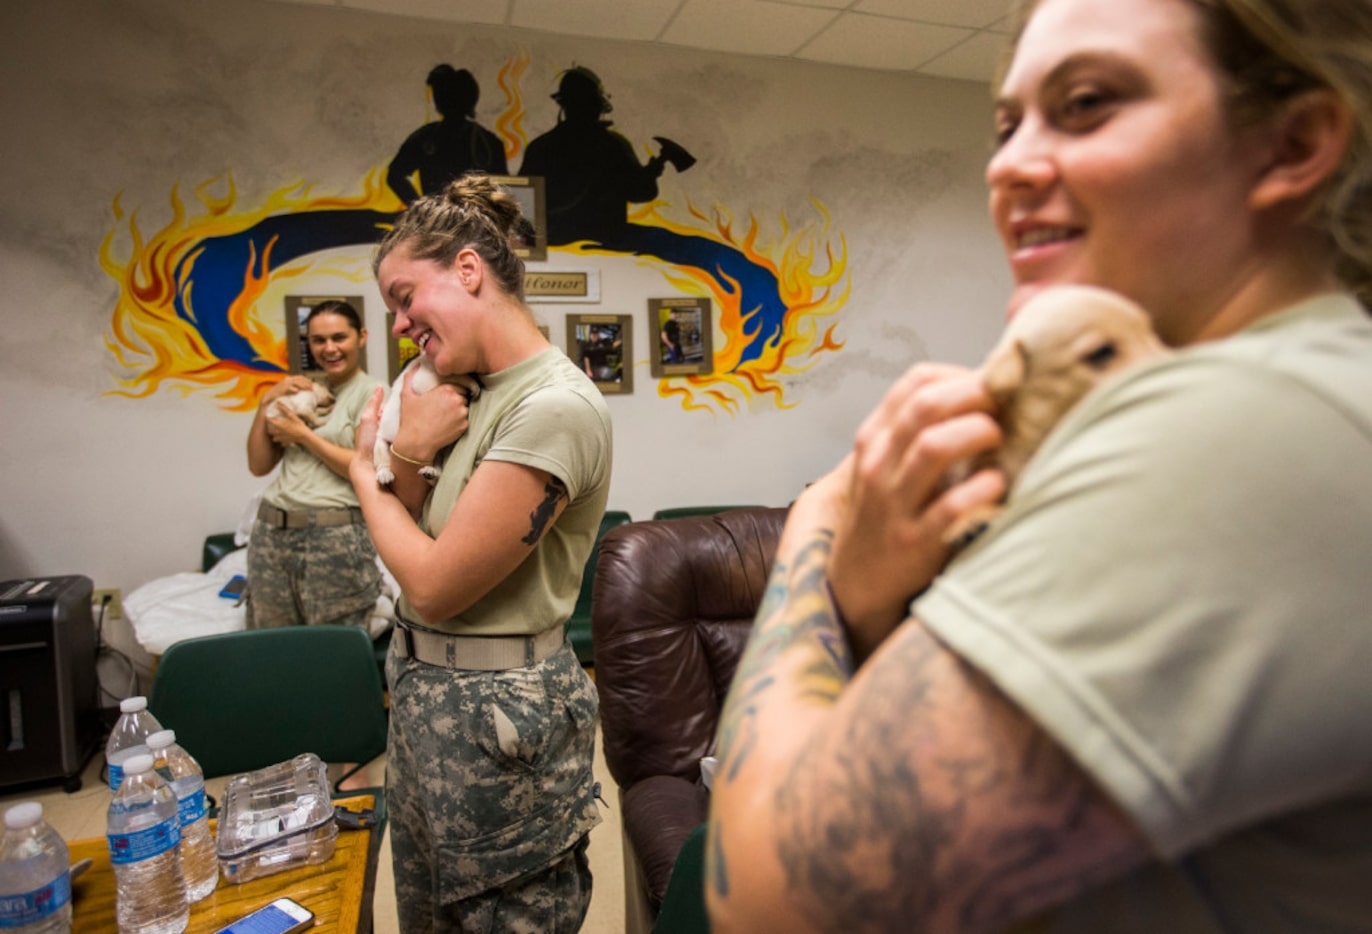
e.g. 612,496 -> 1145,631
996,0 -> 1372,307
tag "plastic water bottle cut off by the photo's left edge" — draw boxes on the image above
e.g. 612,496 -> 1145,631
0,801 -> 71,934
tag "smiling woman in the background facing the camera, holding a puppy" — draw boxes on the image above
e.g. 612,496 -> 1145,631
247,300 -> 381,630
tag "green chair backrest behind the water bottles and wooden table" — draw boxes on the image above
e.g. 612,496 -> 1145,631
148,625 -> 387,778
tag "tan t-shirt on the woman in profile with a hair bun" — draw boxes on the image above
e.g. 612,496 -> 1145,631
401,348 -> 613,635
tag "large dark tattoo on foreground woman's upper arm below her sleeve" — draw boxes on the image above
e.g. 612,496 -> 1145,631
774,628 -> 1146,931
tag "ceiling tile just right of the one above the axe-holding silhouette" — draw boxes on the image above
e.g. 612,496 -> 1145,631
661,0 -> 837,55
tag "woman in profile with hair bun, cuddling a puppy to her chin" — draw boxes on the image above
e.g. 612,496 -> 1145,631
351,176 -> 611,933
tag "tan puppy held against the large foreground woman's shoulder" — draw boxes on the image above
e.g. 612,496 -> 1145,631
947,285 -> 1168,543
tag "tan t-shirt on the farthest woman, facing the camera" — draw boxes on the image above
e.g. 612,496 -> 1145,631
262,370 -> 381,510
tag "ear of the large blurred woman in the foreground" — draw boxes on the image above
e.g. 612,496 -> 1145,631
1250,88 -> 1353,210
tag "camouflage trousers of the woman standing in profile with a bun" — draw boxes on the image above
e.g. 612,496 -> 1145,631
386,642 -> 600,934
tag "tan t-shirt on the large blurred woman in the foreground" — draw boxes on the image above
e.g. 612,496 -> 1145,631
912,295 -> 1372,934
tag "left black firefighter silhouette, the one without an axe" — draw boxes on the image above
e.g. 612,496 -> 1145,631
386,64 -> 509,204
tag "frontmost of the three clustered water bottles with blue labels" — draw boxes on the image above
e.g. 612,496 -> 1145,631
106,753 -> 191,934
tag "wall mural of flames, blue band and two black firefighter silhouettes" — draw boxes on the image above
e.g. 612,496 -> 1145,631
100,53 -> 849,414
